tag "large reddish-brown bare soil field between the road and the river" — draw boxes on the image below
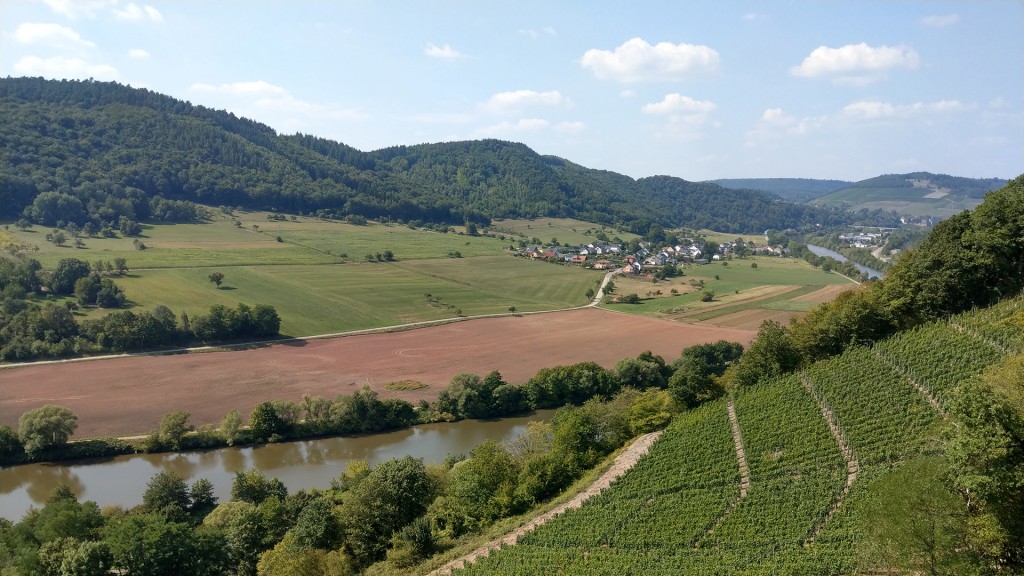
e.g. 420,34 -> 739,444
0,308 -> 753,438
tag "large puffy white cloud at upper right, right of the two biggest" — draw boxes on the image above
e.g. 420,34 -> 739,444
790,42 -> 920,84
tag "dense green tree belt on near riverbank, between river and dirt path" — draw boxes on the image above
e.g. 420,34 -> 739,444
0,383 -> 668,576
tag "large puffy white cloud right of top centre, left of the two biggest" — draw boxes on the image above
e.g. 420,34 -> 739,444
581,38 -> 719,82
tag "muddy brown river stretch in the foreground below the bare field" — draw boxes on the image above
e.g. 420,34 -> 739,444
0,410 -> 554,522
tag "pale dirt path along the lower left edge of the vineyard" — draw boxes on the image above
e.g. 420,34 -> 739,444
427,431 -> 662,576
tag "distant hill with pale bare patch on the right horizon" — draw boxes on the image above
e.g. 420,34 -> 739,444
811,172 -> 1007,217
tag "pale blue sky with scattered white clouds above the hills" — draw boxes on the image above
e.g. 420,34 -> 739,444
0,0 -> 1024,180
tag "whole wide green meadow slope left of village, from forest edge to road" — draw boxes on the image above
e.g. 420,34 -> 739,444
8,212 -> 601,336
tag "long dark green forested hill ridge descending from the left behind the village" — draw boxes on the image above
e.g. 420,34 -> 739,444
0,78 -> 886,233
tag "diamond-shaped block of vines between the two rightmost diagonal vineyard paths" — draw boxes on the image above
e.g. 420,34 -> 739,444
874,322 -> 1004,405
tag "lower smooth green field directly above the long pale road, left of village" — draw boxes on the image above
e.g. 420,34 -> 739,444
91,255 -> 600,336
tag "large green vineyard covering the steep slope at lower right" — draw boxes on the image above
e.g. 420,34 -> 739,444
456,298 -> 1024,575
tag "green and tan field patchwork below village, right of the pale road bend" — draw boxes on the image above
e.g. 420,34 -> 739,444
602,257 -> 852,324
